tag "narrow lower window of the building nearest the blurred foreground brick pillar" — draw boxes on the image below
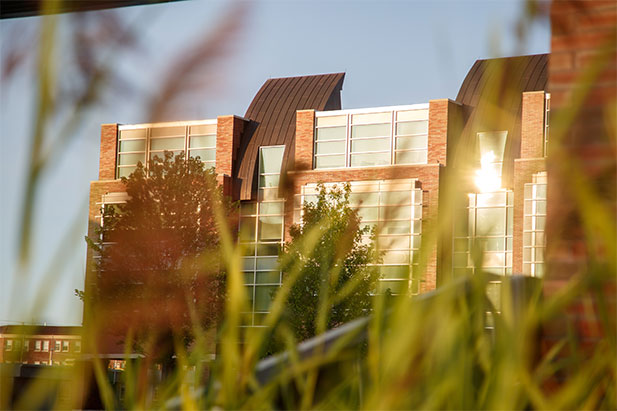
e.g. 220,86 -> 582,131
523,172 -> 546,277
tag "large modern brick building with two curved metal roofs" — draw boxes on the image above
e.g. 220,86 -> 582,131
86,55 -> 550,332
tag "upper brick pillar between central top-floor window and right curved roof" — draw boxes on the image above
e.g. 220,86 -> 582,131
428,99 -> 462,165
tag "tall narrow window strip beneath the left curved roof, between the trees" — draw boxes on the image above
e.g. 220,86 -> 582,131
240,146 -> 285,326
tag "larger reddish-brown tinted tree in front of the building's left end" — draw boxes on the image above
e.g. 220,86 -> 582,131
86,152 -> 234,366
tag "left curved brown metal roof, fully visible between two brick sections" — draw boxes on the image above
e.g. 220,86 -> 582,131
235,73 -> 345,200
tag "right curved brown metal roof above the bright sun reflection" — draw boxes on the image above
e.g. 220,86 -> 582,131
454,54 -> 548,186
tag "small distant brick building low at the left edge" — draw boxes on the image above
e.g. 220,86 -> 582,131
0,325 -> 82,365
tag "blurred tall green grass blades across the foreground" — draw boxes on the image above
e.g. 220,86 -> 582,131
0,0 -> 617,409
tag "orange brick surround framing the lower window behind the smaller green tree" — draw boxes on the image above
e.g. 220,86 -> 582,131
285,164 -> 443,292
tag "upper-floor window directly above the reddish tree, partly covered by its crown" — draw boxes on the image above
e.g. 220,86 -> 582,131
116,120 -> 216,178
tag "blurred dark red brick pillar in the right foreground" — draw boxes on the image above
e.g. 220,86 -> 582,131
543,0 -> 617,358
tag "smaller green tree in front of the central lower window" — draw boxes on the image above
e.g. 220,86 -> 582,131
281,184 -> 379,341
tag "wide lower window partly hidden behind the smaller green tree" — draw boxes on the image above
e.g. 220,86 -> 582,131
294,179 -> 422,294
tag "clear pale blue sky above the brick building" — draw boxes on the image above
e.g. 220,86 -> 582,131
0,0 -> 550,325
